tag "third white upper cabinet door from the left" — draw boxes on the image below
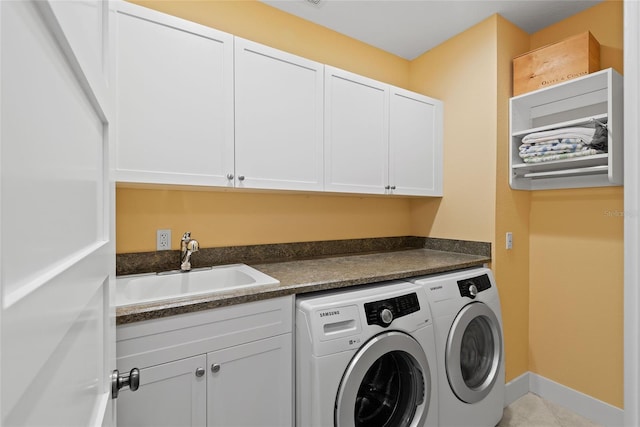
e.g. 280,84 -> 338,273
324,66 -> 389,194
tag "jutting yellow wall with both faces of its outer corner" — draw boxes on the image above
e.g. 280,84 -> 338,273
410,15 -> 530,381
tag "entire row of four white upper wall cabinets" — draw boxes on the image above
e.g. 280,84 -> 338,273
115,2 -> 442,196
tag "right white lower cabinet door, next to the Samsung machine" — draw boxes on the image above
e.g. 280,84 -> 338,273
207,334 -> 293,427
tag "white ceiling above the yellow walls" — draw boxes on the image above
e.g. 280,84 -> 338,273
261,0 -> 602,60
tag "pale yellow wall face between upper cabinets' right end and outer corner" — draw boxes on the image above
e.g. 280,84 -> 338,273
410,16 -> 497,242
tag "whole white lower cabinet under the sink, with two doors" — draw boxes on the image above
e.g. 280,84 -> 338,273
116,296 -> 293,427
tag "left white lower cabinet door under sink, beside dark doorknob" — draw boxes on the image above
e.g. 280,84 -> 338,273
117,354 -> 207,427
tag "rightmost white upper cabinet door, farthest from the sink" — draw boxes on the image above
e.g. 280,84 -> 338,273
389,88 -> 443,196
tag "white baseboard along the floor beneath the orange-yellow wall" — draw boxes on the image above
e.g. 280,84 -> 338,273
505,372 -> 624,427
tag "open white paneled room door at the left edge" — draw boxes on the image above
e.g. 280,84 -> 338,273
0,0 -> 115,426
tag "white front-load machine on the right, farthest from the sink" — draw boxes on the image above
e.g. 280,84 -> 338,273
411,268 -> 505,427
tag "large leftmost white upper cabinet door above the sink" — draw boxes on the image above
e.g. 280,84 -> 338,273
116,2 -> 233,186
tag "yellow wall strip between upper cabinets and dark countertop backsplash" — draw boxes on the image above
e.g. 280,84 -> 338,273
116,189 -> 411,253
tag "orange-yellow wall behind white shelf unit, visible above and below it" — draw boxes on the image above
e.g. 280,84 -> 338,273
529,0 -> 624,407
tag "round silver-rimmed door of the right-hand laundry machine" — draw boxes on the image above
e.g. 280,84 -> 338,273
445,302 -> 502,403
